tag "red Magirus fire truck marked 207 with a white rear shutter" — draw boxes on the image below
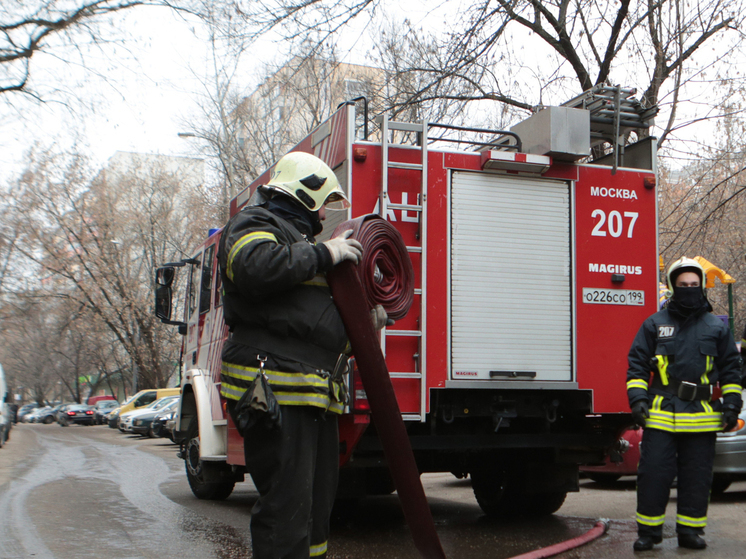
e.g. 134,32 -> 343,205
156,89 -> 658,515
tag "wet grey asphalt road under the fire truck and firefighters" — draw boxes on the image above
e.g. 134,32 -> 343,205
0,425 -> 746,559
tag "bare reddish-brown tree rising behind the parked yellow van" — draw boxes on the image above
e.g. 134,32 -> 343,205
3,149 -> 209,394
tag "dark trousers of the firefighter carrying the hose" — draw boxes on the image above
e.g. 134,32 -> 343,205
244,406 -> 339,559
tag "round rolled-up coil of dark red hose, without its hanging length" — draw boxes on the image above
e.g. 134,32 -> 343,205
332,214 -> 414,320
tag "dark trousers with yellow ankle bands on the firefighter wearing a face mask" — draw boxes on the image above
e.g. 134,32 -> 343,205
637,429 -> 717,537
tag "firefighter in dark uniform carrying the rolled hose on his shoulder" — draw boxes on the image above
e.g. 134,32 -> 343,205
219,152 -> 370,559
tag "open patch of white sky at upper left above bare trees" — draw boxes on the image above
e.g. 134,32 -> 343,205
0,9 -> 217,182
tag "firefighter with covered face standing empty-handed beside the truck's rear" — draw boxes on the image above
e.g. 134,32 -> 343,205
627,257 -> 741,551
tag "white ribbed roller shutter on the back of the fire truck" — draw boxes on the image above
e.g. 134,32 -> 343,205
451,172 -> 572,381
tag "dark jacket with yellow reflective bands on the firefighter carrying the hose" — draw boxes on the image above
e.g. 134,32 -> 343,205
218,206 -> 348,413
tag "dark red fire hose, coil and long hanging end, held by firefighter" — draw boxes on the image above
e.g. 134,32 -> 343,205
327,214 -> 445,559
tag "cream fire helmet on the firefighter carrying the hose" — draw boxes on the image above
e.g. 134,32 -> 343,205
265,151 -> 350,212
